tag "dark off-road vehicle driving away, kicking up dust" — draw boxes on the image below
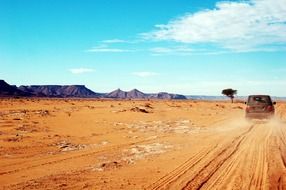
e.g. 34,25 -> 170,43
245,95 -> 276,119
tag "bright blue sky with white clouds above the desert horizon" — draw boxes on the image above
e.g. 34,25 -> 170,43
0,0 -> 286,96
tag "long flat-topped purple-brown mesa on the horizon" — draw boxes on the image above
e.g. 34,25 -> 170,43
19,85 -> 102,98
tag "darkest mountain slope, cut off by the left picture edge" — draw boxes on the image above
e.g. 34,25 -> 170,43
0,80 -> 32,97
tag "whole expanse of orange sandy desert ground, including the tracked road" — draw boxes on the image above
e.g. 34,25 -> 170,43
0,99 -> 286,190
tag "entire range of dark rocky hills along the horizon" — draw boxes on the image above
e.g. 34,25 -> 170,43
0,80 -> 187,99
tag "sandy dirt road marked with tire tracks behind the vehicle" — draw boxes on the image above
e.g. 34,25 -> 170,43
150,119 -> 286,189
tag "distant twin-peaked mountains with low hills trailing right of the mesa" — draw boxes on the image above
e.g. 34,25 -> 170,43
105,89 -> 187,99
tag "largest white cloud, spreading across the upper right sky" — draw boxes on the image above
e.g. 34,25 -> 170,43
143,0 -> 286,51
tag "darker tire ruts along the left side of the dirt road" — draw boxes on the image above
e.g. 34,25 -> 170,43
147,125 -> 254,190
